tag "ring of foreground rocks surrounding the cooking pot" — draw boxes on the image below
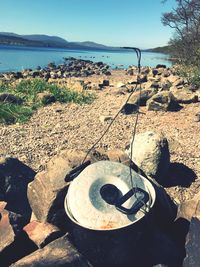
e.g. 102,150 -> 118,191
0,132 -> 200,267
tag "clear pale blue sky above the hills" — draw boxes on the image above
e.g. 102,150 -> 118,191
0,0 -> 175,48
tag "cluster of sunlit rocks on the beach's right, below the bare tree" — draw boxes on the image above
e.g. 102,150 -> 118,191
121,65 -> 200,114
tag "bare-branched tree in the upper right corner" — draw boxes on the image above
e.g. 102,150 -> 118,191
162,0 -> 200,65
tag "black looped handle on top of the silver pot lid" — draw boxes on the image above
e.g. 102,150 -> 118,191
115,188 -> 149,215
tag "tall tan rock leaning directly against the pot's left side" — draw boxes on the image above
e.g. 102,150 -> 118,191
28,150 -> 90,230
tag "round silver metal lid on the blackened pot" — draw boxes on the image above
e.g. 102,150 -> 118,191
65,161 -> 155,230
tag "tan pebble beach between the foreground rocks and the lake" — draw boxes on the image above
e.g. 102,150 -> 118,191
0,63 -> 200,202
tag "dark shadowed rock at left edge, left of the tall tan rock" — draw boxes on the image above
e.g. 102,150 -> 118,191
0,158 -> 35,225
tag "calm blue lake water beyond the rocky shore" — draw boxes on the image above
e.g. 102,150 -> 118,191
0,46 -> 171,72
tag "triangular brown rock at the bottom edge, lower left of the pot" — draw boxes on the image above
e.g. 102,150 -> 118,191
11,235 -> 89,267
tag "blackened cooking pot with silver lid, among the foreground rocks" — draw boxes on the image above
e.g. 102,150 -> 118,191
64,161 -> 156,266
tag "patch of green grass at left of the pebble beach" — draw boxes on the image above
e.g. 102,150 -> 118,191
0,79 -> 94,124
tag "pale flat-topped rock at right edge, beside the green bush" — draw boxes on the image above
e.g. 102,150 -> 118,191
170,87 -> 198,104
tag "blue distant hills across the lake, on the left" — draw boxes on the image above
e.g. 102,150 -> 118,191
0,32 -> 119,50
